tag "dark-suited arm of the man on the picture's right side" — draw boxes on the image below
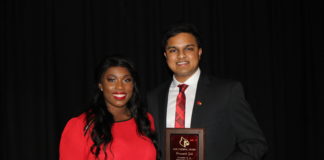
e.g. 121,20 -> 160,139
227,83 -> 268,160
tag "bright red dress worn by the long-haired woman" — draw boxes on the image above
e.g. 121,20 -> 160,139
60,114 -> 156,160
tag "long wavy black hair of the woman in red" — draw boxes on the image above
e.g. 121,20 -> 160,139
84,57 -> 158,158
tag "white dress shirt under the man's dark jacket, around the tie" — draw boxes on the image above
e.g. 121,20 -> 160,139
166,68 -> 200,128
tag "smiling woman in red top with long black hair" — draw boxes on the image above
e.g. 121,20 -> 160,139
60,57 -> 157,160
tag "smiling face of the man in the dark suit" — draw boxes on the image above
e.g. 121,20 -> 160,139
164,33 -> 202,82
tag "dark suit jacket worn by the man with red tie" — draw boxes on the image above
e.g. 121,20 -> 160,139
147,74 -> 267,160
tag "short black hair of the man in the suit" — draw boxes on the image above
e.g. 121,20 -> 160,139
162,24 -> 201,51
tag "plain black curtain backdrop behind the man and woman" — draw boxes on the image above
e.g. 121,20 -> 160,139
0,0 -> 324,160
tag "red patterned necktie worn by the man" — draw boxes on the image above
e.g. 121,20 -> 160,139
175,84 -> 188,128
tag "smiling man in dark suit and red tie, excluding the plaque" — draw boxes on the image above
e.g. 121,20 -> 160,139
147,25 -> 267,160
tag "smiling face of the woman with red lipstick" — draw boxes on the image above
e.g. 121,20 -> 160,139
99,67 -> 134,108
